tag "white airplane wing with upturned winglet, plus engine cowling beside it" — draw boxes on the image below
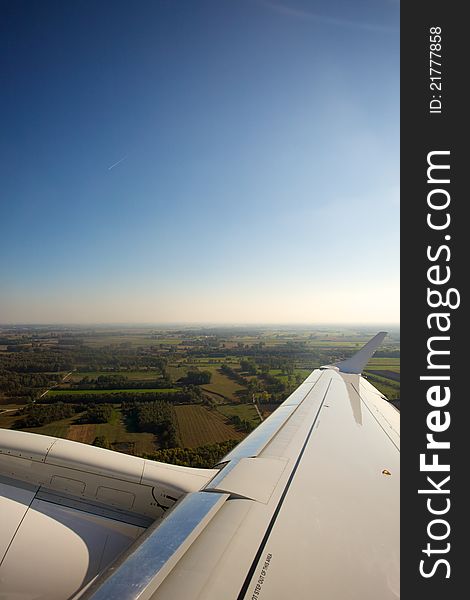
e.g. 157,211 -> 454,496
0,333 -> 400,600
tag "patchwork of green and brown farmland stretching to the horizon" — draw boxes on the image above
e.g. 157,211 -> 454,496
0,326 -> 400,466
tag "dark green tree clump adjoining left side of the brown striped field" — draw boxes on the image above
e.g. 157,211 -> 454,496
122,400 -> 179,448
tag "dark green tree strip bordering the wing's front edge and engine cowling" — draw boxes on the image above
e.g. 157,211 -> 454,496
145,440 -> 239,469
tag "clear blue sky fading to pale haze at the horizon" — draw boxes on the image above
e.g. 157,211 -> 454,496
0,0 -> 399,323
